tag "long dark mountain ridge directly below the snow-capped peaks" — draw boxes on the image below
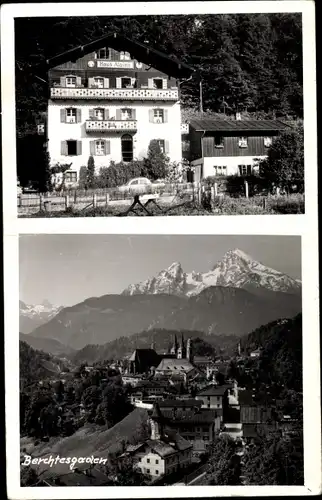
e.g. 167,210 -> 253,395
28,287 -> 301,349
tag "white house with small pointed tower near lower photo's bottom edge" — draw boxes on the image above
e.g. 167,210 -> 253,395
124,404 -> 192,480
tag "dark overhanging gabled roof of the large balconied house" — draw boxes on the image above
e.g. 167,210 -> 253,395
41,33 -> 195,78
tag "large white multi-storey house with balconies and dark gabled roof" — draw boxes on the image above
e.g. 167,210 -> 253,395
46,34 -> 193,186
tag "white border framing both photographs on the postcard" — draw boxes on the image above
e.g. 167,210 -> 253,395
1,0 -> 321,500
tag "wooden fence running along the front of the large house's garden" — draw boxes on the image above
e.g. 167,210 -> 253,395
17,181 -> 304,214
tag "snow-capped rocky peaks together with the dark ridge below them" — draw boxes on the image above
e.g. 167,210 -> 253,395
21,250 -> 301,354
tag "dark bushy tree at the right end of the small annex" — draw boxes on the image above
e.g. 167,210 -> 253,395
259,126 -> 304,192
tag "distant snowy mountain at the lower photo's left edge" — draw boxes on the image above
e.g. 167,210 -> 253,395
19,300 -> 62,334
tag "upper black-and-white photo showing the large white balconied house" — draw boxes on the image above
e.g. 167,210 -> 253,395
15,7 -> 304,218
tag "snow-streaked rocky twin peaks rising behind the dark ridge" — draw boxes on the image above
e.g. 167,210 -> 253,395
123,249 -> 301,297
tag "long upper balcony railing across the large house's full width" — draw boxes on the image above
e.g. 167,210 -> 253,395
50,87 -> 179,101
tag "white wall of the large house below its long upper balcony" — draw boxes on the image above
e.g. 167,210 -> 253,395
48,99 -> 182,181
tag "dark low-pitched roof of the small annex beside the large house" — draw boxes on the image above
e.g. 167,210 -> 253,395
190,118 -> 291,133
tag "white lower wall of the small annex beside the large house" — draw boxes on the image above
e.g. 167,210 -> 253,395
191,156 -> 266,180
